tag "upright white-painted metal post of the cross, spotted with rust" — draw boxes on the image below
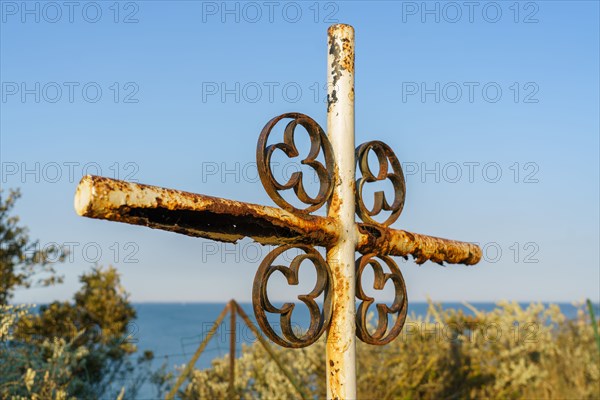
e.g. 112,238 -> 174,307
326,24 -> 358,399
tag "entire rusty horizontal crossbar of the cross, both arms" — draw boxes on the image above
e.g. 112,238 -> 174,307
75,176 -> 481,265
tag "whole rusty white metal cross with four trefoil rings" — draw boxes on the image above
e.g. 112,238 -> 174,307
75,24 -> 481,399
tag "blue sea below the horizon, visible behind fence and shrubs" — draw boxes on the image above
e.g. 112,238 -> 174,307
127,302 -> 600,399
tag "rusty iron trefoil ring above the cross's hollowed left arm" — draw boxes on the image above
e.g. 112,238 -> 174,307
256,113 -> 334,214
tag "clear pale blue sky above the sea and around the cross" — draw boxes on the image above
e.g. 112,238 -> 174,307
0,1 -> 600,303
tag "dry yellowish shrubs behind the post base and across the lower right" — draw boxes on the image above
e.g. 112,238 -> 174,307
180,302 -> 600,399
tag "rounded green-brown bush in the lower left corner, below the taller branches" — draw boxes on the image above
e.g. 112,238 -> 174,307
0,268 -> 157,399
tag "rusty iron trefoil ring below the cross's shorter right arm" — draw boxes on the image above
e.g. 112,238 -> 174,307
356,254 -> 408,346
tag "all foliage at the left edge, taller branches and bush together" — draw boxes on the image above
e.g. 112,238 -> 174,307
0,191 -> 157,400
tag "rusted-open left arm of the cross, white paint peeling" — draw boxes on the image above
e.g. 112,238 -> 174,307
75,176 -> 337,245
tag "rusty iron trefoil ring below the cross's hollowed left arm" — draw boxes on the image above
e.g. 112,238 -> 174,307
252,245 -> 332,348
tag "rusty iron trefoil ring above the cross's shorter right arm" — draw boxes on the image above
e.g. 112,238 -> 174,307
356,140 -> 406,226
